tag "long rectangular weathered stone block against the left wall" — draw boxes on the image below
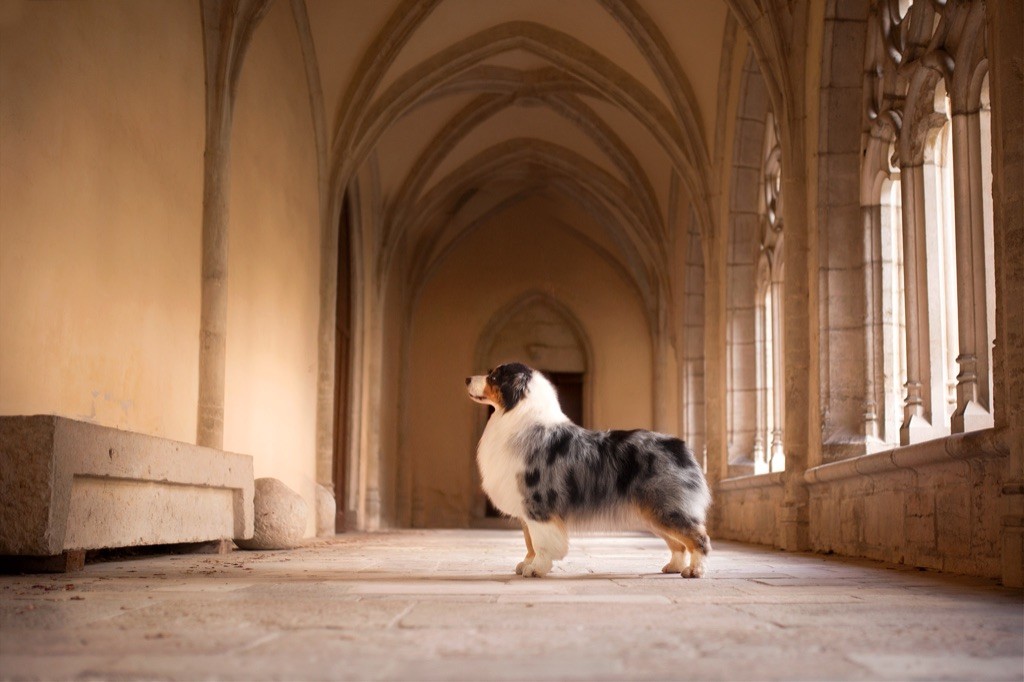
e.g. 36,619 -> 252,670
0,415 -> 253,556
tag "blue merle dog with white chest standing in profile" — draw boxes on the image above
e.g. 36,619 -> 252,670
466,363 -> 711,578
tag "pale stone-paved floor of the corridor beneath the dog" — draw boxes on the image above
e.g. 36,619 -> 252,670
0,530 -> 1024,680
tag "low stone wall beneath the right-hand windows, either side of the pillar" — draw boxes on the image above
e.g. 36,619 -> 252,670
713,429 -> 1019,582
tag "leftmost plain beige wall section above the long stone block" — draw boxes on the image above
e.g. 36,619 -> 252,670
0,0 -> 204,441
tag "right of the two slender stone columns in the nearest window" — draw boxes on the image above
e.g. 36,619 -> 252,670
952,112 -> 992,433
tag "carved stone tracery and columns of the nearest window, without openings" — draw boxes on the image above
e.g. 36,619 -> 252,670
862,0 -> 992,444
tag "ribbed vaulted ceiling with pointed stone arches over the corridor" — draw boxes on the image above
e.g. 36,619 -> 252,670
307,0 -> 728,307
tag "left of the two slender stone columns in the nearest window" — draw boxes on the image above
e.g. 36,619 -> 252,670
900,164 -> 933,445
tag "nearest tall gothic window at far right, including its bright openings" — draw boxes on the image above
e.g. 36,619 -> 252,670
861,0 -> 994,444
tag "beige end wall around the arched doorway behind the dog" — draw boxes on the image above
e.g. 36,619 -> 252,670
401,196 -> 652,526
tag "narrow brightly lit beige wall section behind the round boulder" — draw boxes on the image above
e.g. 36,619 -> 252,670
224,2 -> 319,535
